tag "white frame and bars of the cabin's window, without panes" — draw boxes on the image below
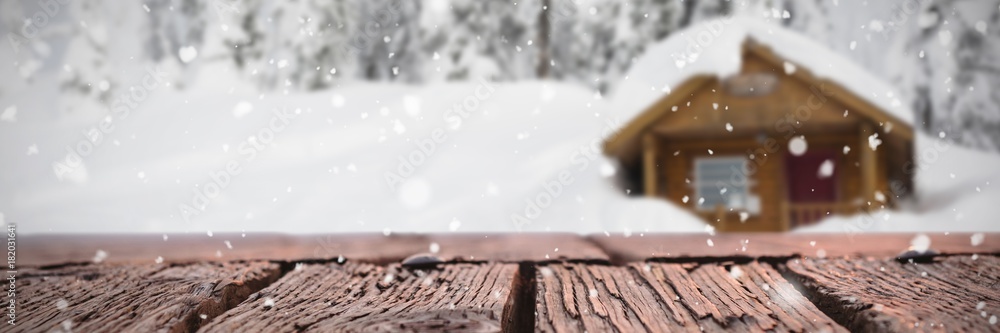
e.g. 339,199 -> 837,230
693,155 -> 759,213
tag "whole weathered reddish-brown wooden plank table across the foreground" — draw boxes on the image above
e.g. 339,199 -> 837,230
5,234 -> 1000,332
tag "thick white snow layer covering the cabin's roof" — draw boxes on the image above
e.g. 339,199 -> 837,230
613,17 -> 913,126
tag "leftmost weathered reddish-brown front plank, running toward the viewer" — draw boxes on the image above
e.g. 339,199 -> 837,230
15,262 -> 281,332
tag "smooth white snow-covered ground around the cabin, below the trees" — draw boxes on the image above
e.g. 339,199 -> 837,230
0,71 -> 1000,235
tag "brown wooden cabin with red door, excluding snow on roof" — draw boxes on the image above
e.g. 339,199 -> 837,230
604,39 -> 913,231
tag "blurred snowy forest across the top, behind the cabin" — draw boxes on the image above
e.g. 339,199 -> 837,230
0,0 -> 1000,151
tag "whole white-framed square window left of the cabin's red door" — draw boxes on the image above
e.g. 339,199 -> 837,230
694,156 -> 753,210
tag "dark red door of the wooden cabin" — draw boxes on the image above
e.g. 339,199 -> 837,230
785,150 -> 837,227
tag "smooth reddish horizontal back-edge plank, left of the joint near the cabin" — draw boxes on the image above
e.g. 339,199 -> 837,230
18,233 -> 608,267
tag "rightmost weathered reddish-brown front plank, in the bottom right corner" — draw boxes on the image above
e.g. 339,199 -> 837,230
787,255 -> 1000,332
